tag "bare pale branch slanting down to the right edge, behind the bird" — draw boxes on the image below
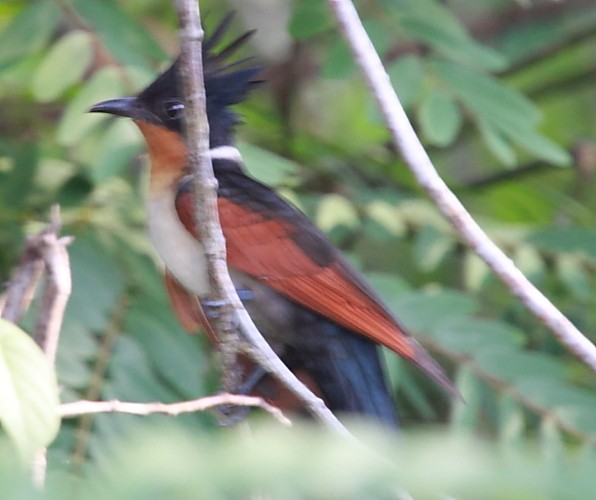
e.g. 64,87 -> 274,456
329,0 -> 596,371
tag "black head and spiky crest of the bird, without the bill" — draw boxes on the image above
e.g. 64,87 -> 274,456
137,14 -> 261,147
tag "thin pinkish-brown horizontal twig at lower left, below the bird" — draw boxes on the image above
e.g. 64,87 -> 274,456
59,394 -> 292,426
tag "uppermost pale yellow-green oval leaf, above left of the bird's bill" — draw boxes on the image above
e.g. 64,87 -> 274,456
31,30 -> 93,102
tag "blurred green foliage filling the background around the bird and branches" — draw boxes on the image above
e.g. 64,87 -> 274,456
0,0 -> 596,499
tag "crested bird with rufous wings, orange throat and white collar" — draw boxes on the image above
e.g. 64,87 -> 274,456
89,16 -> 458,427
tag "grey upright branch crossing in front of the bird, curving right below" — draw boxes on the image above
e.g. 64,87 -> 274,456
175,0 -> 349,435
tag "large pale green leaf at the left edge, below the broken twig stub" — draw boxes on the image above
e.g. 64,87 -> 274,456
0,319 -> 60,460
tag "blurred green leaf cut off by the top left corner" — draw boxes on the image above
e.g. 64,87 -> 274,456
0,0 -> 60,65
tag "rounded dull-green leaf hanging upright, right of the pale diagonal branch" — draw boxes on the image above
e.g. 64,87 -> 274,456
418,85 -> 463,146
